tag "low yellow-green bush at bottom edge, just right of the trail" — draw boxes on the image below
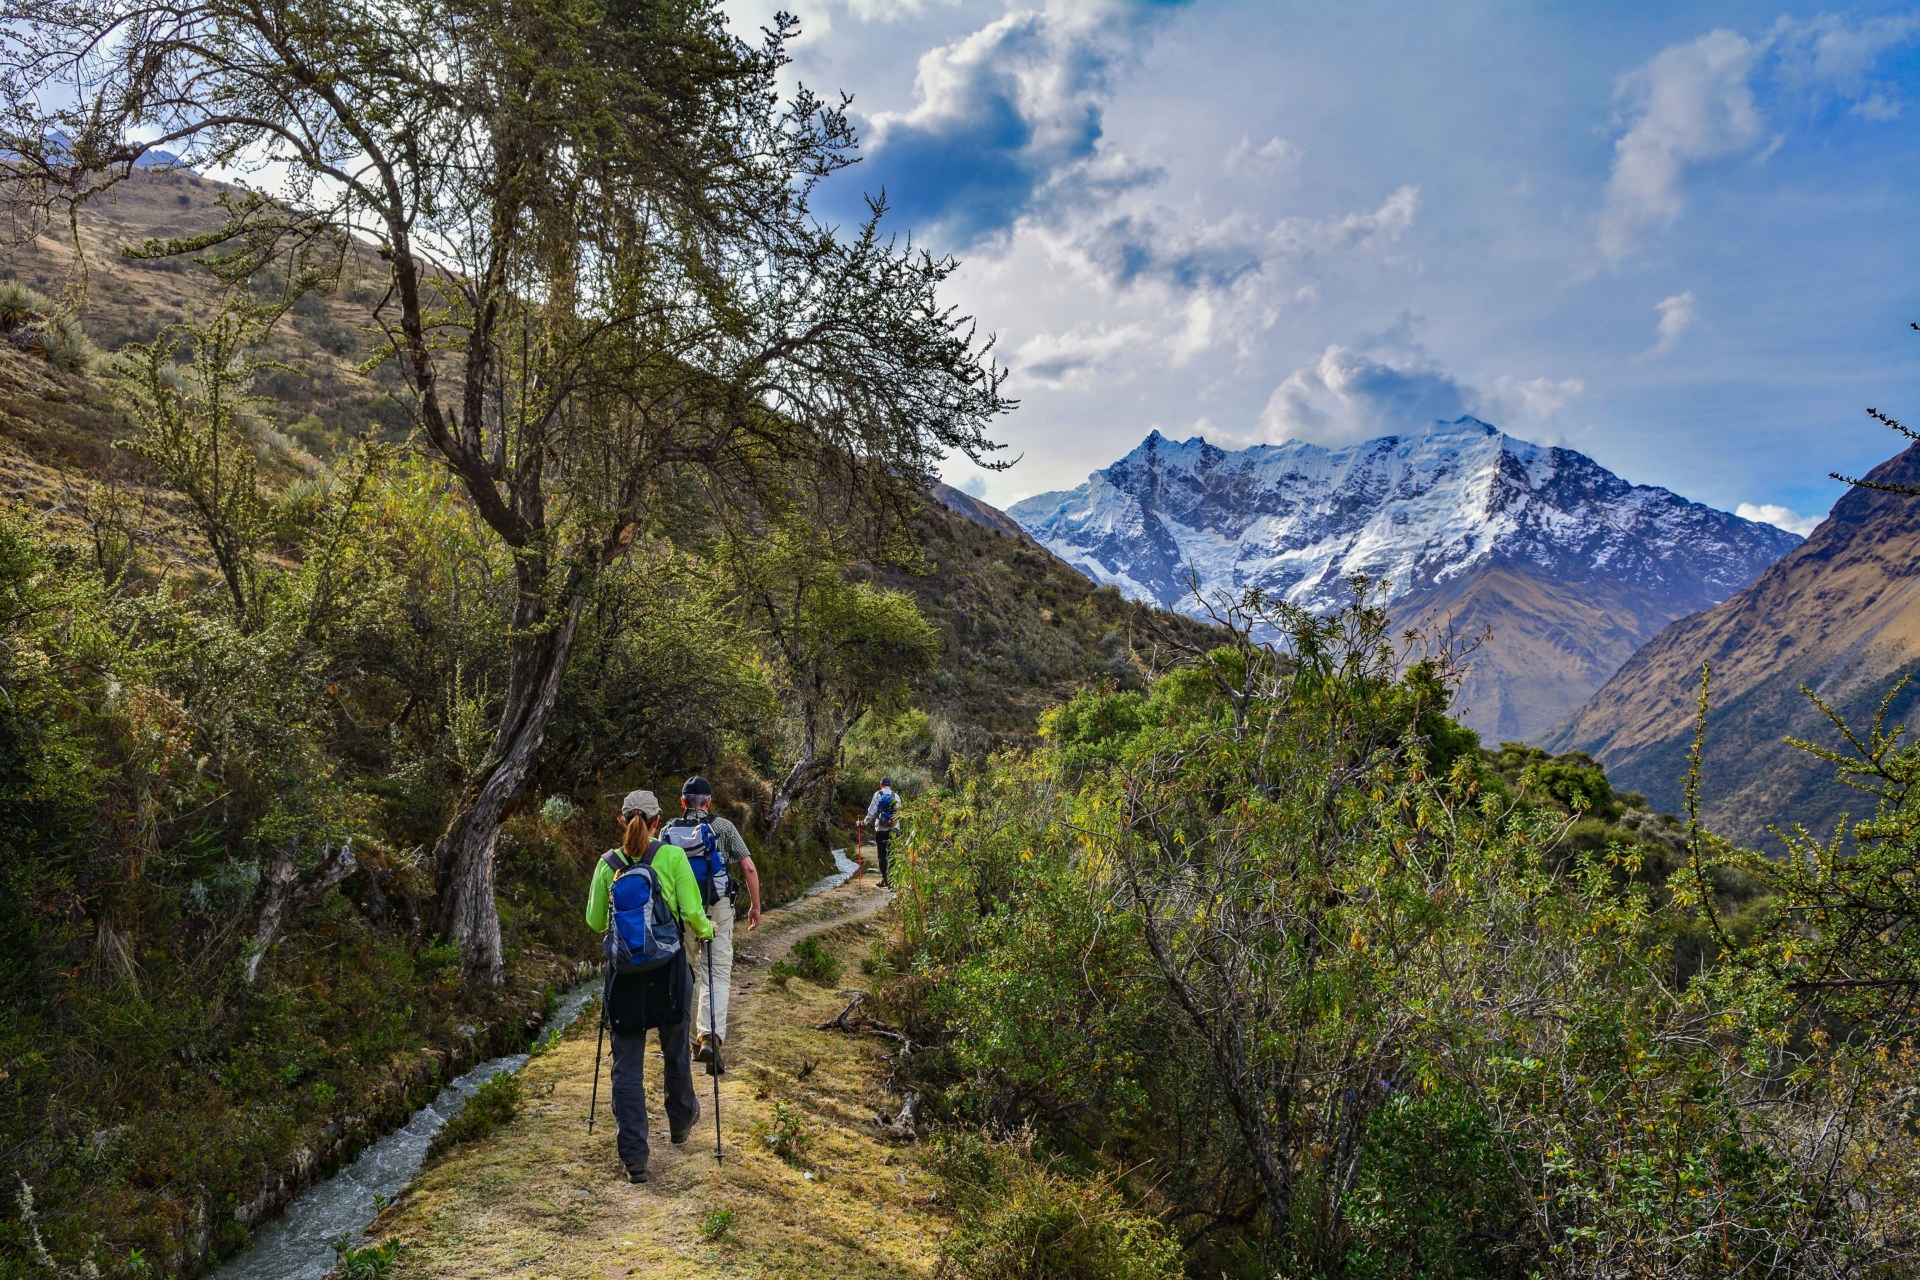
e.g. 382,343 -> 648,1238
935,1132 -> 1185,1280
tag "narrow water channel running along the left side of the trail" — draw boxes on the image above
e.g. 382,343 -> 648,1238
213,848 -> 860,1280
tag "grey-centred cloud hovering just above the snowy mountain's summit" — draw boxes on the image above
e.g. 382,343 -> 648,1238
1260,337 -> 1586,445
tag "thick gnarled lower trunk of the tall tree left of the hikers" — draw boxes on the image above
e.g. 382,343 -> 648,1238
434,587 -> 588,984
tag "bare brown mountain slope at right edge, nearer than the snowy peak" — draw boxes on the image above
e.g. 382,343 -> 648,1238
1544,445 -> 1920,842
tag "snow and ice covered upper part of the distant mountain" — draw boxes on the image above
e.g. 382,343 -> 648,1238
1008,416 -> 1801,612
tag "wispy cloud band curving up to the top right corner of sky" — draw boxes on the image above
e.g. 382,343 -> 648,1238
1597,15 -> 1920,263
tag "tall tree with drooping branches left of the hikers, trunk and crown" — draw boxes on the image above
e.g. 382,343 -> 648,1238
0,0 -> 1008,981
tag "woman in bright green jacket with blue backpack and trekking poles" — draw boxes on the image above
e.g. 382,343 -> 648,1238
588,791 -> 714,1182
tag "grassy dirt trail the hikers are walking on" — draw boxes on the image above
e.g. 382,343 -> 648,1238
372,859 -> 941,1280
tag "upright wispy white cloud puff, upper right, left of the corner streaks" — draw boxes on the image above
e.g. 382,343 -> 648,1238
1599,31 -> 1766,263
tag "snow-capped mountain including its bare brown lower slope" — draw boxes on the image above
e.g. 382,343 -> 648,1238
1008,418 -> 1801,737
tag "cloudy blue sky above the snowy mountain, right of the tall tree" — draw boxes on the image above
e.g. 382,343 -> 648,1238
733,0 -> 1920,528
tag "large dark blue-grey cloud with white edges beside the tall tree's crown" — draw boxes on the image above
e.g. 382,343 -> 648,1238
870,0 -> 1154,246
